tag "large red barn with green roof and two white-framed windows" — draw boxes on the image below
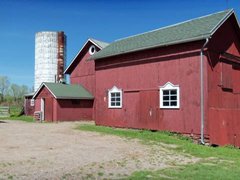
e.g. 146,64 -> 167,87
88,10 -> 240,146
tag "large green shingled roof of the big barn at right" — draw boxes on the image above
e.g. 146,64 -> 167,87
90,9 -> 234,60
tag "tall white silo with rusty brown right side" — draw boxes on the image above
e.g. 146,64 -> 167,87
34,32 -> 66,91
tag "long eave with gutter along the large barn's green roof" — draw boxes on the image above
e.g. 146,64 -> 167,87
89,34 -> 211,60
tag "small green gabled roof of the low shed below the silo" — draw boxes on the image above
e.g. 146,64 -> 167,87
33,83 -> 94,99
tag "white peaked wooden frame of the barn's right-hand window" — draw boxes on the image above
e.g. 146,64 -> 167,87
160,82 -> 180,109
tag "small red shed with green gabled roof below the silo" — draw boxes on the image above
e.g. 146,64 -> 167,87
33,83 -> 94,122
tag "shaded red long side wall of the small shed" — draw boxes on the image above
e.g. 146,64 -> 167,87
56,99 -> 93,121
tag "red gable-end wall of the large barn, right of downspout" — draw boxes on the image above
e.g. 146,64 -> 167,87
205,14 -> 240,147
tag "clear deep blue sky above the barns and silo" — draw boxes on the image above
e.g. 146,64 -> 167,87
0,0 -> 240,88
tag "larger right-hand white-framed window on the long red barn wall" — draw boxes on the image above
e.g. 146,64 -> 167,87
160,82 -> 180,109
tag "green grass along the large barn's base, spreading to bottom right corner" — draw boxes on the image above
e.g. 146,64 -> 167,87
77,125 -> 240,179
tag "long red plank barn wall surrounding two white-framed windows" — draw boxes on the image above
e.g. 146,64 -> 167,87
95,42 -> 207,134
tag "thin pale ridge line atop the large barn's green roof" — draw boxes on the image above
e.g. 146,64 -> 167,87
113,9 -> 233,43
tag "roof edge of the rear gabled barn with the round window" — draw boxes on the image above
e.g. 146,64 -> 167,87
64,38 -> 109,74
